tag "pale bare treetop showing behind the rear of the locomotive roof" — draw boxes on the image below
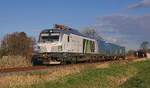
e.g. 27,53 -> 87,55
81,27 -> 103,40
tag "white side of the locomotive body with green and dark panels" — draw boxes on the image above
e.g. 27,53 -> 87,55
62,34 -> 98,54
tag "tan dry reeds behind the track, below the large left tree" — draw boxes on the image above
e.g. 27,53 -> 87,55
0,56 -> 31,69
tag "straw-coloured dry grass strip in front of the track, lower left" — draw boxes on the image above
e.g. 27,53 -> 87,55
0,67 -> 81,88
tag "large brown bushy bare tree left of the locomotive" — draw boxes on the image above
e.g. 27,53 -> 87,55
1,32 -> 35,57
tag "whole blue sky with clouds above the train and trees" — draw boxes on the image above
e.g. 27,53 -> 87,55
0,0 -> 150,49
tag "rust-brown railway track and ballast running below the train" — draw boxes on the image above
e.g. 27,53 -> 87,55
0,61 -> 109,77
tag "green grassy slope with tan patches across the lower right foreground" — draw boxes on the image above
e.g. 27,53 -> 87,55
14,61 -> 150,88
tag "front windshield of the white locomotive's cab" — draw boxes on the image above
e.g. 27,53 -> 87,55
39,33 -> 59,42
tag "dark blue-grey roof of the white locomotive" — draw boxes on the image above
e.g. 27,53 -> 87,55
41,28 -> 94,39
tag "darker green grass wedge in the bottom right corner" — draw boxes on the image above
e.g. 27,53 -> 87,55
122,62 -> 150,88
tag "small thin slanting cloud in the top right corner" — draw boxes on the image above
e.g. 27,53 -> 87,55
126,0 -> 150,10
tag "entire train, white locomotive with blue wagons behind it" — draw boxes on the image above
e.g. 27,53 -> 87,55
31,24 -> 125,65
